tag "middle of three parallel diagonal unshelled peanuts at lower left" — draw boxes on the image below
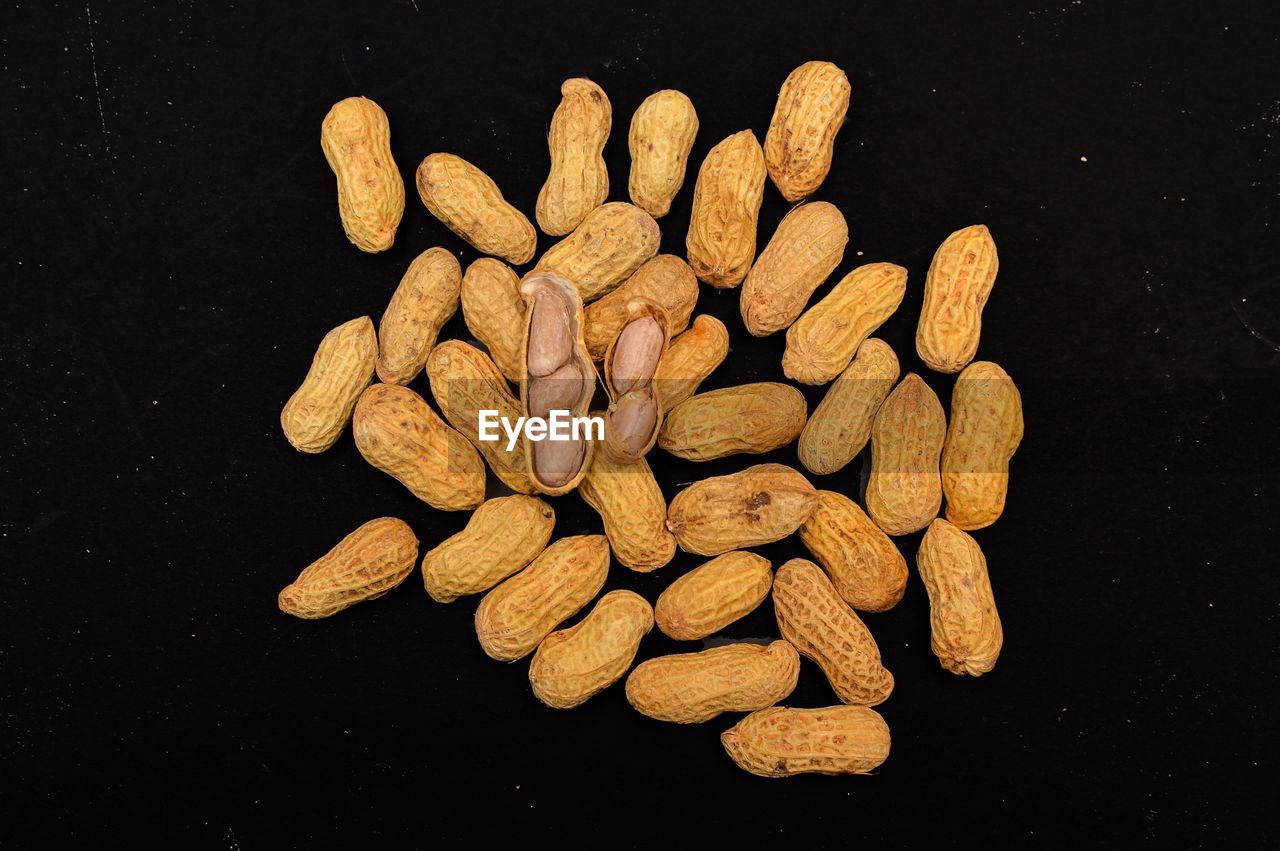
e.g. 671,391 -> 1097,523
476,535 -> 609,662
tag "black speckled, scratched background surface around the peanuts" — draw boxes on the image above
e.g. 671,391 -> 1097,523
0,0 -> 1280,848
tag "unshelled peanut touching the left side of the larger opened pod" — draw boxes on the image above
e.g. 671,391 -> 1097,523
426,340 -> 535,494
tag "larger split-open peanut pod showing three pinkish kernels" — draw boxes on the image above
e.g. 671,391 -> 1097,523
520,271 -> 598,497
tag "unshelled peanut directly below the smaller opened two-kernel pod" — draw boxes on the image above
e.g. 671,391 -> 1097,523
577,437 -> 676,573
